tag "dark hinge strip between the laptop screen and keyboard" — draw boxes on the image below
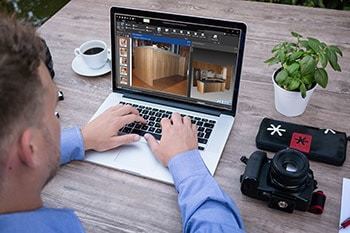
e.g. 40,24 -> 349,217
123,93 -> 221,116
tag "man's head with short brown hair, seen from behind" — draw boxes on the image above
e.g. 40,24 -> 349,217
0,14 -> 60,208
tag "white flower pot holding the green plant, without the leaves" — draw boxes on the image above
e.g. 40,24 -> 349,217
272,70 -> 317,117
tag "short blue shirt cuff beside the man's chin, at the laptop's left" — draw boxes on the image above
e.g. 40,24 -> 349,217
60,127 -> 85,165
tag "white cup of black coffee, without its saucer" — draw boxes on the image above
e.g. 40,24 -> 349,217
74,40 -> 108,69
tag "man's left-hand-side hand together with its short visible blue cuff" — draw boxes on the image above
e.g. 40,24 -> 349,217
60,105 -> 145,165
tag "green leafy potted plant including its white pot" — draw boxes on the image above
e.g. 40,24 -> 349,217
265,32 -> 343,116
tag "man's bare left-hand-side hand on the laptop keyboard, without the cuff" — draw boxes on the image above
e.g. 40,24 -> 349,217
82,105 -> 146,151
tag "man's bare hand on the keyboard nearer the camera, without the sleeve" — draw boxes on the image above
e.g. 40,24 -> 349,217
144,113 -> 198,166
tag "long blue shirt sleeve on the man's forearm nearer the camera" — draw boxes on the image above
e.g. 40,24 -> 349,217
168,150 -> 244,233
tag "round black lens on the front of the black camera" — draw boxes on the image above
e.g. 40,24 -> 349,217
270,149 -> 309,191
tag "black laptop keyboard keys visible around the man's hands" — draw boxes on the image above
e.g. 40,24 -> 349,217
120,102 -> 216,150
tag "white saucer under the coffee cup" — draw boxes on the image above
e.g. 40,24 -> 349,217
72,55 -> 111,77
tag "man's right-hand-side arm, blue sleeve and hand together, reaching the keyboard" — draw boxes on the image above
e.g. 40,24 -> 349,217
145,113 -> 244,233
